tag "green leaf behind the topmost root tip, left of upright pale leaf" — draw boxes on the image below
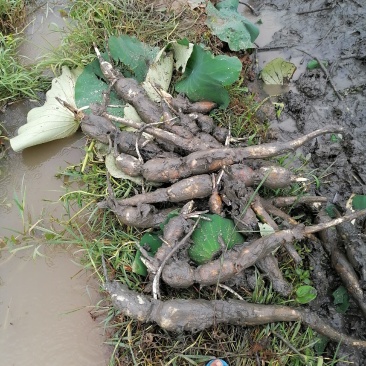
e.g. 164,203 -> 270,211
108,35 -> 159,83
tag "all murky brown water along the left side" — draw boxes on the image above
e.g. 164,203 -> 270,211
0,2 -> 109,366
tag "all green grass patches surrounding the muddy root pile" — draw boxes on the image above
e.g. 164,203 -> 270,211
0,0 -> 352,366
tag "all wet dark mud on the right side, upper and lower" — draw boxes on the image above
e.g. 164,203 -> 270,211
251,0 -> 366,365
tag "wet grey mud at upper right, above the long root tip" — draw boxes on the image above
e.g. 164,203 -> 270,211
242,0 -> 366,207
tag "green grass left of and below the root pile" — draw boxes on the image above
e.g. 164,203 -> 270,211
50,155 -> 340,366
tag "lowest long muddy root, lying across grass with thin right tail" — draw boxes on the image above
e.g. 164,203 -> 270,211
105,282 -> 366,348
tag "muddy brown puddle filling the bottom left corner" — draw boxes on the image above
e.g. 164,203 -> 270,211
0,247 -> 108,366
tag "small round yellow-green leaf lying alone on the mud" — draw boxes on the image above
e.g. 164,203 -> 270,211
261,57 -> 296,85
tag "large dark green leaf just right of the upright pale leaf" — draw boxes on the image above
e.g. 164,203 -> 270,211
175,45 -> 242,108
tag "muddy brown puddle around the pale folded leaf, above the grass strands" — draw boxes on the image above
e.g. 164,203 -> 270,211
0,102 -> 84,236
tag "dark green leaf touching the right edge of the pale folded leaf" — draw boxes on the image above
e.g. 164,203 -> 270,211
75,58 -> 123,117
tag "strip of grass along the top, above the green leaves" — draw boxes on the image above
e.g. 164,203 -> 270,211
39,0 -> 202,69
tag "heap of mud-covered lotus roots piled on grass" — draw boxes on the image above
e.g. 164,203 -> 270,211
59,48 -> 366,347
